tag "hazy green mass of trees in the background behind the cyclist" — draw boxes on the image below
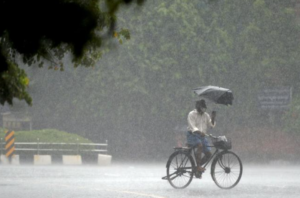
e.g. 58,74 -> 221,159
14,0 -> 300,159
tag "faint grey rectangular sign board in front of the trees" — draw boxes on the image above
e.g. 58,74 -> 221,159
258,87 -> 292,110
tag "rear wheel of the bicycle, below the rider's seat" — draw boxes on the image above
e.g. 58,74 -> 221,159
167,151 -> 195,189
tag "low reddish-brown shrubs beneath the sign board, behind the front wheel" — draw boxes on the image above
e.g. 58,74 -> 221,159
227,126 -> 300,163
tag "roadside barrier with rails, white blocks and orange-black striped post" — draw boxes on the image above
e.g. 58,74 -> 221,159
0,139 -> 111,165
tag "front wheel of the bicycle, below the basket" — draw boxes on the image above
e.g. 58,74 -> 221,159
211,151 -> 243,189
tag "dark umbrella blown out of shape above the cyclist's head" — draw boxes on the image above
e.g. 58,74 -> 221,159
193,85 -> 233,105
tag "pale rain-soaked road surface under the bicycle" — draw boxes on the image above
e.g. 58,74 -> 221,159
0,164 -> 300,198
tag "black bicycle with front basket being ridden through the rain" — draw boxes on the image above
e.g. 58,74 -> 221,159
162,135 -> 243,189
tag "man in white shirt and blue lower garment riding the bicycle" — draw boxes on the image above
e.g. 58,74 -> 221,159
187,100 -> 216,178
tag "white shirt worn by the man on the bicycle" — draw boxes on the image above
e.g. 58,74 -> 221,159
187,109 -> 216,133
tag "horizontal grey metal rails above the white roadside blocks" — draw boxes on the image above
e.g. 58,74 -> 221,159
0,138 -> 108,155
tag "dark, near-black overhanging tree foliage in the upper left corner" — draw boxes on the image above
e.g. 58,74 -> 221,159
0,0 -> 143,105
